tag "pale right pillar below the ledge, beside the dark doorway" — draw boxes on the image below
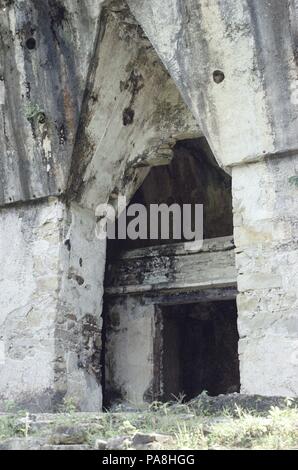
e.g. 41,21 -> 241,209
232,155 -> 298,396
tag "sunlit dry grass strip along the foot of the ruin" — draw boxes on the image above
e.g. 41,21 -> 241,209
0,399 -> 298,450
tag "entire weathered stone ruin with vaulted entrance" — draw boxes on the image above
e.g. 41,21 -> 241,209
0,0 -> 298,412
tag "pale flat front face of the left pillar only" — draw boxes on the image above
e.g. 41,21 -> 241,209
0,200 -> 63,410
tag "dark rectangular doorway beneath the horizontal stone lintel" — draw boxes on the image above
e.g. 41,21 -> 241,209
158,300 -> 240,401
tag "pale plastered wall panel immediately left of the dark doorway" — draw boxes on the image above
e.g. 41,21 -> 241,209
105,297 -> 155,405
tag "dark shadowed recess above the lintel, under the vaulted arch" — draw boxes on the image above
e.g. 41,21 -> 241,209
107,138 -> 233,262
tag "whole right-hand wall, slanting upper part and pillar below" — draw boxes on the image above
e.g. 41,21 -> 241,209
128,0 -> 298,395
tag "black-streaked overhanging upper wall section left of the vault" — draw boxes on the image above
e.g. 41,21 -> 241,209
0,0 -> 103,205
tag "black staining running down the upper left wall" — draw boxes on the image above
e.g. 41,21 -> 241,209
0,0 -> 81,201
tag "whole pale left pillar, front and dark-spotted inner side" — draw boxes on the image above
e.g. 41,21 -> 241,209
0,198 -> 105,412
